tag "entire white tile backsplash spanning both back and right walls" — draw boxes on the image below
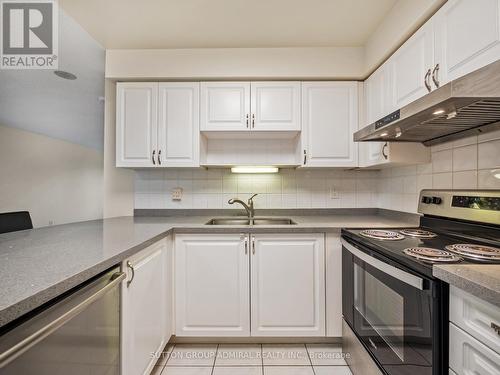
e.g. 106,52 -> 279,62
135,136 -> 500,212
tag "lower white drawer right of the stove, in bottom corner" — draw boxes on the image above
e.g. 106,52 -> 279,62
450,323 -> 500,375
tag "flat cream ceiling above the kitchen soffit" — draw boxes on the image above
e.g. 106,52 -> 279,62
59,0 -> 396,49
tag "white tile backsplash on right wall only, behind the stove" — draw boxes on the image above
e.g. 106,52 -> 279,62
378,131 -> 500,212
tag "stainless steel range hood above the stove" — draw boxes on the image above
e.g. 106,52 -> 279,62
354,60 -> 500,146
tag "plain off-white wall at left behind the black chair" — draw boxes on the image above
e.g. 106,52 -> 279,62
0,126 -> 103,227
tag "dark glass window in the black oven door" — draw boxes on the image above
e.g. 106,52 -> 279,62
354,263 -> 405,362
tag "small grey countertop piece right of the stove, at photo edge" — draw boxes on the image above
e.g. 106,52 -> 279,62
432,264 -> 500,307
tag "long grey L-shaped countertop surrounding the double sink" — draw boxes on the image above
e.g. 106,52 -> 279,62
0,210 -> 418,327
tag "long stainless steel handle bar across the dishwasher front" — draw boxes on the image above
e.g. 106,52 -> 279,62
0,271 -> 126,369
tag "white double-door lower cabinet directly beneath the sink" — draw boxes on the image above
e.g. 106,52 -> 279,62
175,233 -> 330,337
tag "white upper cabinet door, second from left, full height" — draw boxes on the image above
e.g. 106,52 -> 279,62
158,82 -> 200,167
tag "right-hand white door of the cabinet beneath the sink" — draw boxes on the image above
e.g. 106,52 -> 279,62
251,233 -> 325,337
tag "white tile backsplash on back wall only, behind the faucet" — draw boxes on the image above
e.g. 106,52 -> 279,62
135,169 -> 378,209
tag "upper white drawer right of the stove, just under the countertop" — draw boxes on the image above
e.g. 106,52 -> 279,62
450,287 -> 500,353
